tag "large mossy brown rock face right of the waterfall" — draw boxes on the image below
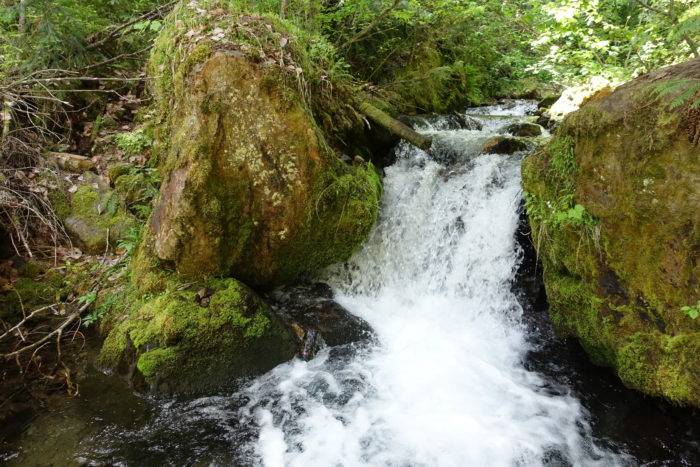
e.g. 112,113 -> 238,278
523,59 -> 700,406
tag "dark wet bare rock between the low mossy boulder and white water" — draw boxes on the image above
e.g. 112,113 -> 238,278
267,282 -> 374,358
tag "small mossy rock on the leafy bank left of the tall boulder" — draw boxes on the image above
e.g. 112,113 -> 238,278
63,185 -> 136,254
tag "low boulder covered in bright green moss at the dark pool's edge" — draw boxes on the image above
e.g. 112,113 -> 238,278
98,279 -> 297,395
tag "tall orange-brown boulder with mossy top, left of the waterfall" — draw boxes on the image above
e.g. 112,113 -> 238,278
146,2 -> 381,286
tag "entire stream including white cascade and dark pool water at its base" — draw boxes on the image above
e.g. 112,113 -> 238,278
0,101 -> 700,467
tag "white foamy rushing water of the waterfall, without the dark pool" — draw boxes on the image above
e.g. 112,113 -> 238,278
230,105 -> 622,467
